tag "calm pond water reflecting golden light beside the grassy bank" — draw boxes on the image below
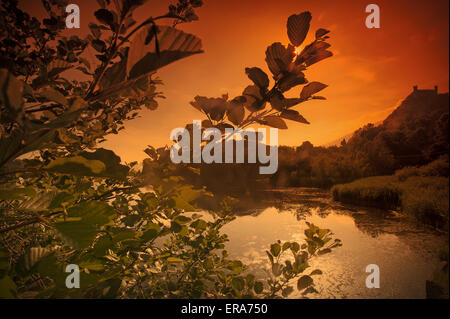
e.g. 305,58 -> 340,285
223,189 -> 448,298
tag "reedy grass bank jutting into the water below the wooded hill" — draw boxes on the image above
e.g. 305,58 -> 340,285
331,157 -> 449,230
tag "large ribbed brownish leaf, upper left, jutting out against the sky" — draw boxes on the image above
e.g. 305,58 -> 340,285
127,26 -> 203,79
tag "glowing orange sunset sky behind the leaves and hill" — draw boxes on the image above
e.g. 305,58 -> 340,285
26,0 -> 449,161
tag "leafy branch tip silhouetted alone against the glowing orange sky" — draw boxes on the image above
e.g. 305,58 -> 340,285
186,12 -> 332,133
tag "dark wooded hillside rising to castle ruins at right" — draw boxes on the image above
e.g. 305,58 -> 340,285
271,87 -> 449,187
